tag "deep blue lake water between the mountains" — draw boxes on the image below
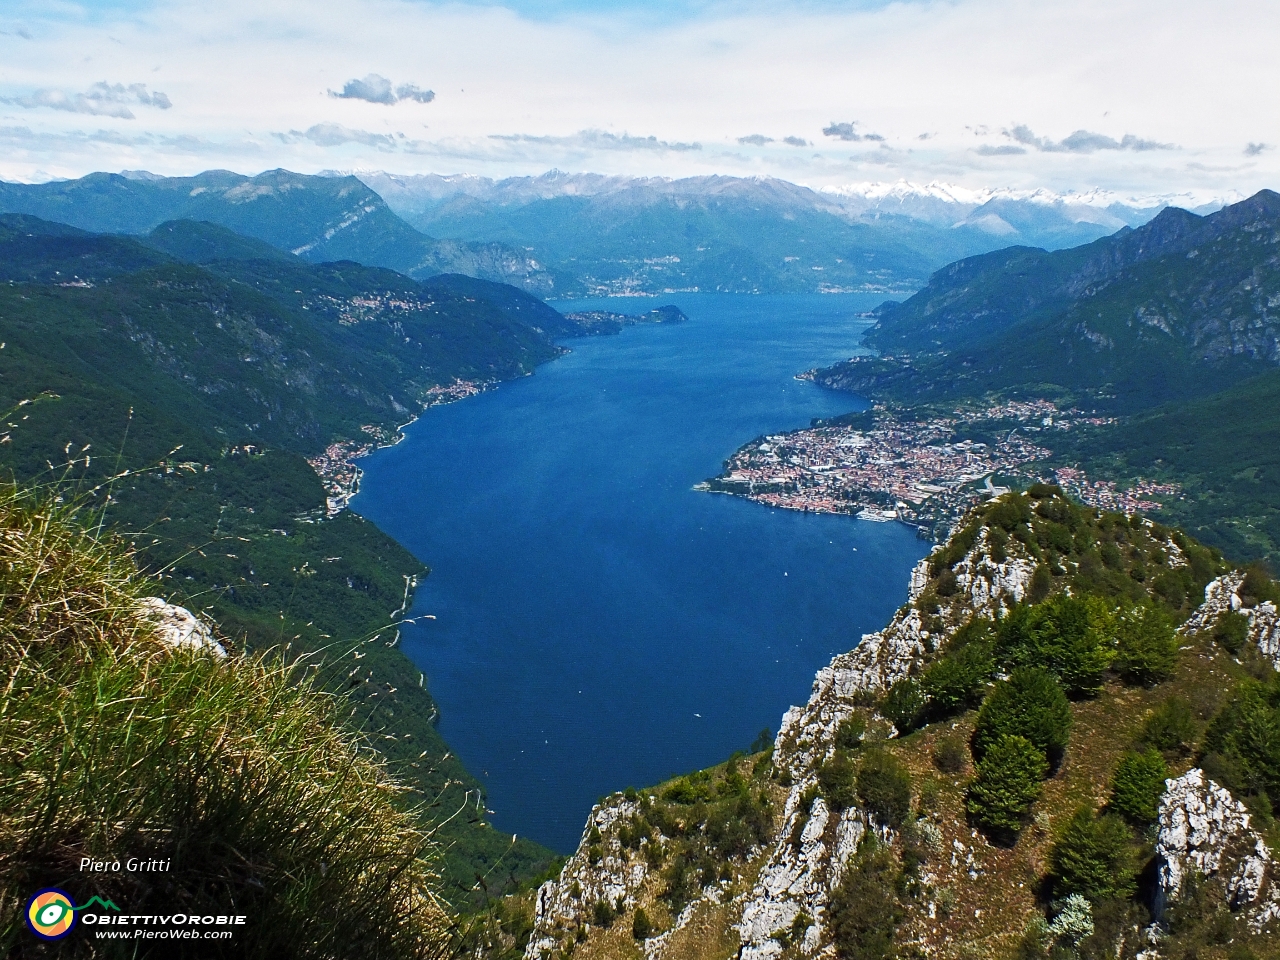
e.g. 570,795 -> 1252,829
353,294 -> 927,851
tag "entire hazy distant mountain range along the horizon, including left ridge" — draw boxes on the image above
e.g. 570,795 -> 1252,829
0,170 -> 1223,300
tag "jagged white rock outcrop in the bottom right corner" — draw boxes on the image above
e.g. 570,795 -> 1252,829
1156,769 -> 1280,924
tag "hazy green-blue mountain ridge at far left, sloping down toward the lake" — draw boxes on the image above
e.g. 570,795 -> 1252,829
0,170 -> 554,294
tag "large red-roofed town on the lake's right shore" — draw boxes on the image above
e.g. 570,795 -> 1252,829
698,399 -> 1179,538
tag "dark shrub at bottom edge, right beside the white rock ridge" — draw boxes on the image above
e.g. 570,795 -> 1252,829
827,841 -> 904,960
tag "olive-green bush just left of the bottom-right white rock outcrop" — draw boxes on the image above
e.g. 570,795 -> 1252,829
1050,806 -> 1135,901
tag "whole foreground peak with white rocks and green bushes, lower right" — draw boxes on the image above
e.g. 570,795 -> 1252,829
486,485 -> 1280,960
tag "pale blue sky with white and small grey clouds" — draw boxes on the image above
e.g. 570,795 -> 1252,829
0,0 -> 1280,201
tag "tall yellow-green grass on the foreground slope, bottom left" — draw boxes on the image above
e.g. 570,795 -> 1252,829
0,488 -> 447,957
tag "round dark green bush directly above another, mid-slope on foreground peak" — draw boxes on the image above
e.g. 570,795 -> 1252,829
973,667 -> 1071,764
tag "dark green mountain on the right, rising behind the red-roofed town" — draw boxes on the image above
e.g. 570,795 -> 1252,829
819,191 -> 1280,411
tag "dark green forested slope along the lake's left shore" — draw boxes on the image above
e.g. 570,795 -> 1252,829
0,229 -> 556,902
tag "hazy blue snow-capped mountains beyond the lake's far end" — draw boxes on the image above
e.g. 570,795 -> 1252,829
360,170 -> 1158,296
